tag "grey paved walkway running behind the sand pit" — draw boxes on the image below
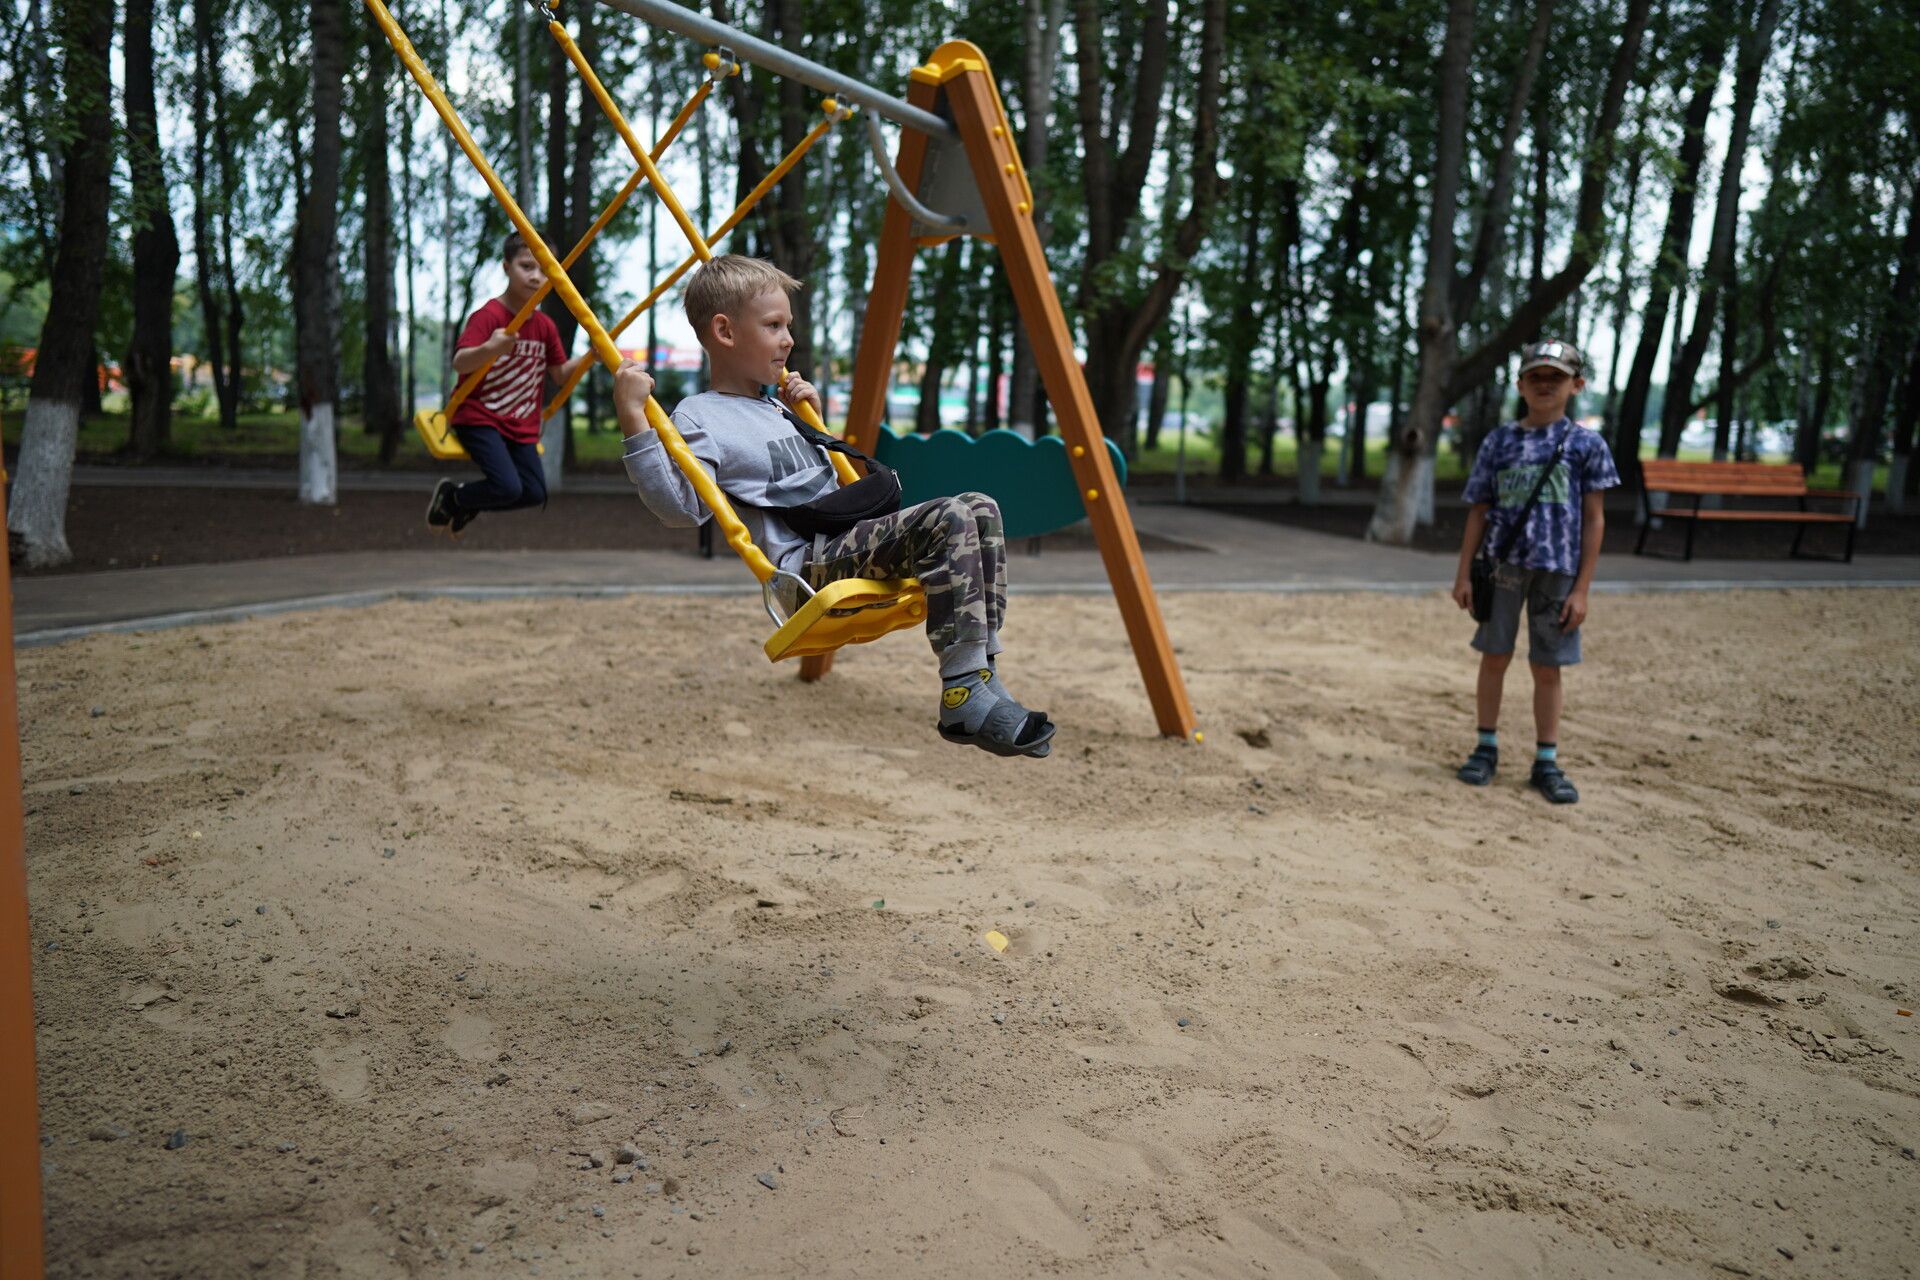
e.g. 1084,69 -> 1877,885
13,505 -> 1920,645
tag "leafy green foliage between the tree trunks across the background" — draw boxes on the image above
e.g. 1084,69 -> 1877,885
0,0 -> 1920,479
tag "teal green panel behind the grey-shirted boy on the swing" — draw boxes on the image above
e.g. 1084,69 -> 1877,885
874,426 -> 1127,537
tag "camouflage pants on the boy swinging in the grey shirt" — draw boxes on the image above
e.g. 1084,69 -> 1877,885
806,493 -> 1006,666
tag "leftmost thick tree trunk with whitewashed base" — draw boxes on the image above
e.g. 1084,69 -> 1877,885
8,0 -> 113,568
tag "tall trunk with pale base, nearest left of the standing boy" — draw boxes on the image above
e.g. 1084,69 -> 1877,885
1367,0 -> 1473,547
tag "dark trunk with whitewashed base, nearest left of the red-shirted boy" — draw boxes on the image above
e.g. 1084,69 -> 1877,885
294,0 -> 346,507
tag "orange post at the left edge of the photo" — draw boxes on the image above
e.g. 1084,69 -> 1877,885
0,472 -> 46,1280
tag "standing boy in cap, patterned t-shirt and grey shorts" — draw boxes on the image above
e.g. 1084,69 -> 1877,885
1453,342 -> 1620,804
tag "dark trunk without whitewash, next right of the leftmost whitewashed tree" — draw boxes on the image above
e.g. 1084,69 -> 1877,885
125,0 -> 180,459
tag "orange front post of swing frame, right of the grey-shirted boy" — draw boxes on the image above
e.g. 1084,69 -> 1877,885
933,40 -> 1200,741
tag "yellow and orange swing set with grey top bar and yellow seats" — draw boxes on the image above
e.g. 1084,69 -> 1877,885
363,0 -> 1202,741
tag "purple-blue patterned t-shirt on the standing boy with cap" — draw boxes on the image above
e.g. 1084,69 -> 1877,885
1463,418 -> 1620,576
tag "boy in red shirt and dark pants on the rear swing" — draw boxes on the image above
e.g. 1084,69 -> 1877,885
426,234 -> 593,537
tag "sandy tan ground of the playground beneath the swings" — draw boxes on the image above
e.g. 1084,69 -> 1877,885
21,591 -> 1920,1278
